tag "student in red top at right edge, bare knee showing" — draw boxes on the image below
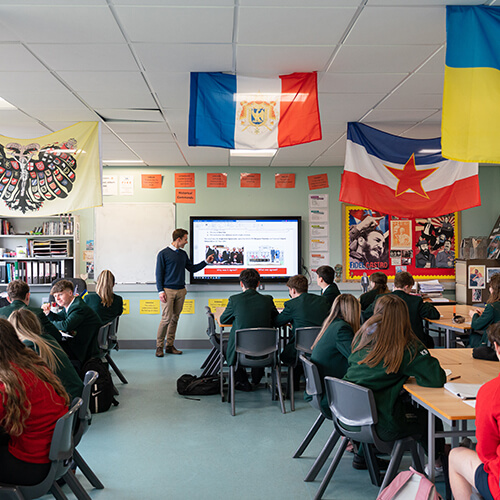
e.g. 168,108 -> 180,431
449,323 -> 500,500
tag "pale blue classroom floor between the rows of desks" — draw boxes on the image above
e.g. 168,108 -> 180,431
56,350 -> 448,500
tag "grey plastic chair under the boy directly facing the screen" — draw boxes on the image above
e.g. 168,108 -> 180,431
229,328 -> 286,416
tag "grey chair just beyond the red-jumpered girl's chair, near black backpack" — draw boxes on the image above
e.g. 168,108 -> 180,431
60,370 -> 104,500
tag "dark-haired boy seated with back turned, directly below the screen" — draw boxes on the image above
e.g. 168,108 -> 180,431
220,269 -> 278,391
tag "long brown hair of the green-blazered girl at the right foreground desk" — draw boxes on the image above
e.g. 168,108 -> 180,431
353,293 -> 418,373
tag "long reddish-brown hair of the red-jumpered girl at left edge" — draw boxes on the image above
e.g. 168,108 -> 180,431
0,318 -> 69,436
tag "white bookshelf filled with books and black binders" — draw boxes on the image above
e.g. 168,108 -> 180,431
0,215 -> 80,290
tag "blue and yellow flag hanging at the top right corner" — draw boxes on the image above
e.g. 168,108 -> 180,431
441,6 -> 500,163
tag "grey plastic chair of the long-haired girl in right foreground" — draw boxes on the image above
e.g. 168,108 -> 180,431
315,377 -> 424,500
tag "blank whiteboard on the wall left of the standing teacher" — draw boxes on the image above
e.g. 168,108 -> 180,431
94,203 -> 175,283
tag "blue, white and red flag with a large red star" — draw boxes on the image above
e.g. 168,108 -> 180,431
340,123 -> 481,218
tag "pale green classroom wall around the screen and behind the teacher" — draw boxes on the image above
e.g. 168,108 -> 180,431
34,165 -> 500,347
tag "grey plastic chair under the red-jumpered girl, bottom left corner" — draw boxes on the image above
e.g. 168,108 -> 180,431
0,398 -> 83,500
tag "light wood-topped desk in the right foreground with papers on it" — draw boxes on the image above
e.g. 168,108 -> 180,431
404,348 -> 500,481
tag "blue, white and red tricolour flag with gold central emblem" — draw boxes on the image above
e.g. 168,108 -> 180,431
188,73 -> 321,149
